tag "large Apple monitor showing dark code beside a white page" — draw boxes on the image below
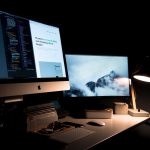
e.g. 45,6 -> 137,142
0,12 -> 69,102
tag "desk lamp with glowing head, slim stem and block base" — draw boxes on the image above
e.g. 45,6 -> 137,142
128,57 -> 150,117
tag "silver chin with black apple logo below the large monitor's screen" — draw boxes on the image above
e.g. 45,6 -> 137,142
0,81 -> 70,97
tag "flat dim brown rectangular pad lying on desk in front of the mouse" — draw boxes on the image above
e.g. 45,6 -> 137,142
50,128 -> 95,144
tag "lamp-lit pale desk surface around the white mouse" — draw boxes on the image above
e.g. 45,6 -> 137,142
57,115 -> 148,150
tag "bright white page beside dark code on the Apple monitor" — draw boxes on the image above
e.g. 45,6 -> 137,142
29,21 -> 66,78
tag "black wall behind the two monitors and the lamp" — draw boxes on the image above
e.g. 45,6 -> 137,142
0,0 -> 150,148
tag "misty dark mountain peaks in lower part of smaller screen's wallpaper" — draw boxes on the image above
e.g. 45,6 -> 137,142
65,71 -> 129,97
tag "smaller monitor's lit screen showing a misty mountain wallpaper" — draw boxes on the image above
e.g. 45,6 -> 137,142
63,54 -> 130,97
